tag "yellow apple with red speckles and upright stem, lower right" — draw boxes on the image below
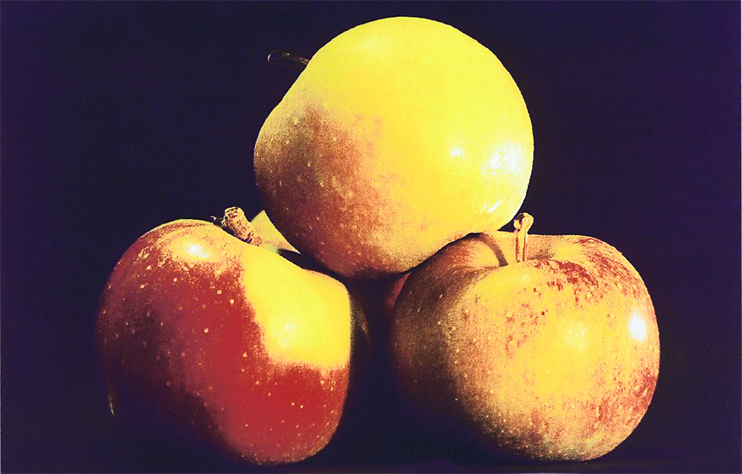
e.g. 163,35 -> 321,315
391,232 -> 660,460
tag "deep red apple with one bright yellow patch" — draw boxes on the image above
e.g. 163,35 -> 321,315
96,220 -> 355,465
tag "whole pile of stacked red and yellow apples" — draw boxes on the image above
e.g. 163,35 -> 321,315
96,18 -> 659,465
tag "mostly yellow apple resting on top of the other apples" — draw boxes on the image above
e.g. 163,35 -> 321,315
255,17 -> 533,277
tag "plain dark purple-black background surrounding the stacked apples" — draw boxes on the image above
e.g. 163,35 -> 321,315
0,2 -> 741,472
